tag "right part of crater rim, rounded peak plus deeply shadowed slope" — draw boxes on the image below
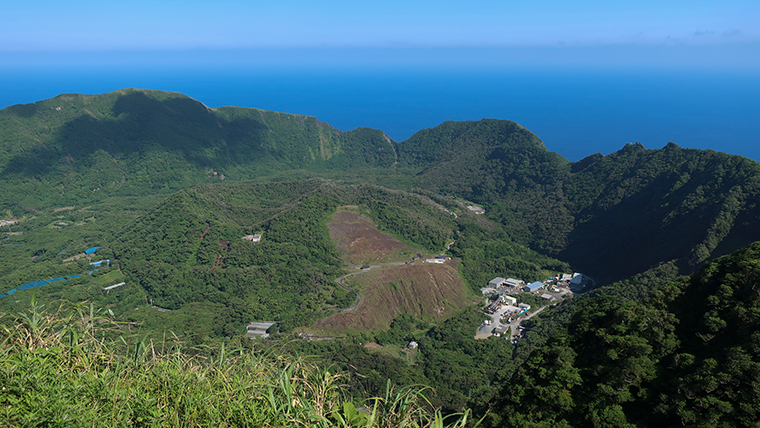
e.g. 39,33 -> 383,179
398,119 -> 760,283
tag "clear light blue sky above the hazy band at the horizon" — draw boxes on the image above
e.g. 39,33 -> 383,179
0,0 -> 760,68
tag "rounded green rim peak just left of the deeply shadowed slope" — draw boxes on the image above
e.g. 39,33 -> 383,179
398,119 -> 572,251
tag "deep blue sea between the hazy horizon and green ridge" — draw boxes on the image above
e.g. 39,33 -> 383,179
0,64 -> 760,161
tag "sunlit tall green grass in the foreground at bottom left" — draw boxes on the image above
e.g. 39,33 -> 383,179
0,301 -> 478,428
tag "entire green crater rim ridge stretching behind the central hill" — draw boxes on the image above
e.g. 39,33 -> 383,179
0,89 -> 760,283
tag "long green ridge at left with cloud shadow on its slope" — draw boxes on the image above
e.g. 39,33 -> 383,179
0,89 -> 396,211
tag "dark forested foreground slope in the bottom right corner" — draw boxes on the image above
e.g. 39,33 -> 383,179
492,243 -> 760,427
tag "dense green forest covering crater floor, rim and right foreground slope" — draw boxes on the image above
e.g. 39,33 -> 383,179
0,89 -> 760,427
